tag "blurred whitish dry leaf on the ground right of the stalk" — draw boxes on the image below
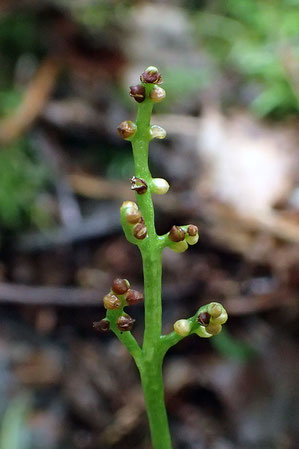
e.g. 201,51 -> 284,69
198,110 -> 296,218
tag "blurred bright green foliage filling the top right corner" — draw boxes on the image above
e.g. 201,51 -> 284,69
192,0 -> 299,117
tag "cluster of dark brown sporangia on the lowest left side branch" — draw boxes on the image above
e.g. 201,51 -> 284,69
93,279 -> 143,332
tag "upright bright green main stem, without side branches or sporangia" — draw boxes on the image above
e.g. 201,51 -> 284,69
132,86 -> 172,449
